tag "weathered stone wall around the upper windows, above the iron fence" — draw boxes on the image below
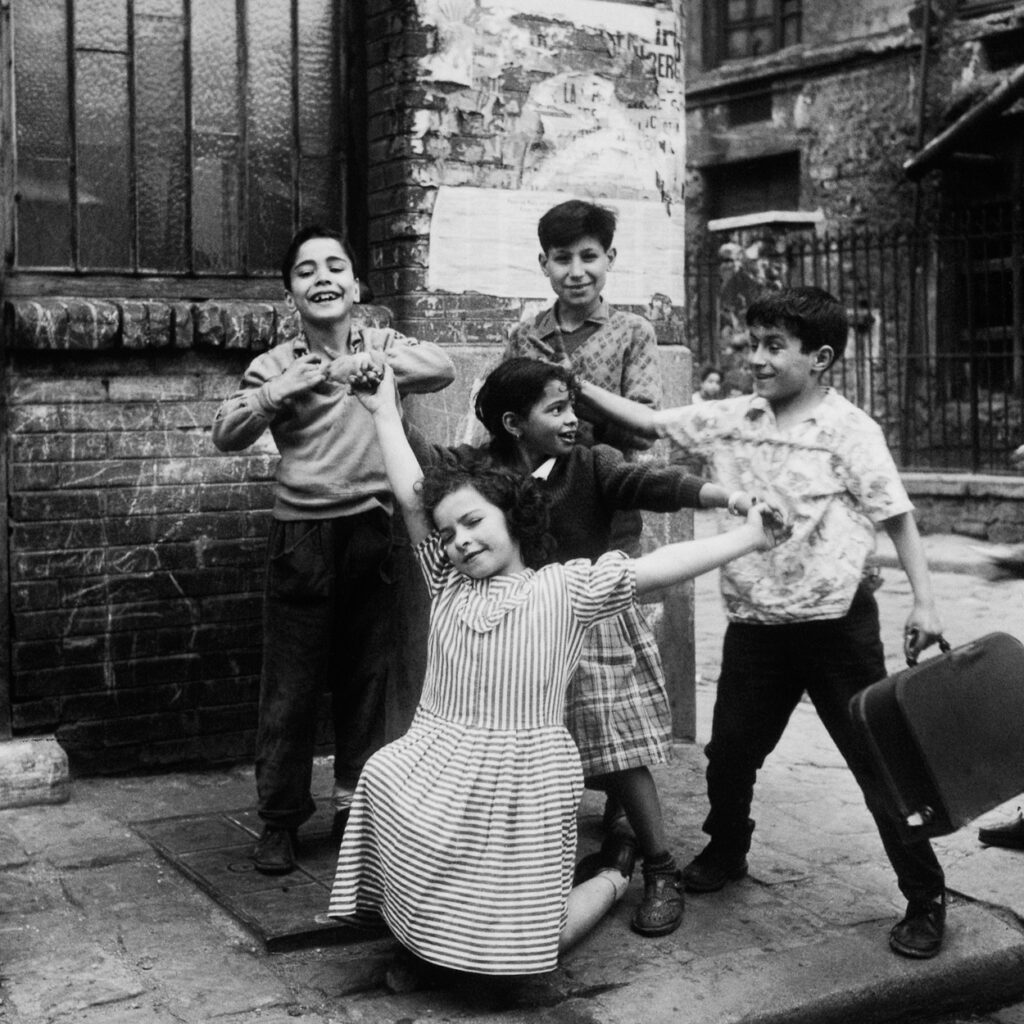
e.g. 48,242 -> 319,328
686,0 -> 1024,234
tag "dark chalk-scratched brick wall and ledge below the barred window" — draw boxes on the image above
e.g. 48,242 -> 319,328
4,299 -> 386,772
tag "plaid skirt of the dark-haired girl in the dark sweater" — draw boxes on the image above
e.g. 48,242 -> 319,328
565,604 -> 672,778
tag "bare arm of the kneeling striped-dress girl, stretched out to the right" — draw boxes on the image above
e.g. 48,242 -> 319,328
634,504 -> 791,594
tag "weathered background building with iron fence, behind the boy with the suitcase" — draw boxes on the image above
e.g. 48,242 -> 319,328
686,0 -> 1024,528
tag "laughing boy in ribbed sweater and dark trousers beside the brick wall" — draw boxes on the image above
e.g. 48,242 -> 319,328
213,225 -> 455,874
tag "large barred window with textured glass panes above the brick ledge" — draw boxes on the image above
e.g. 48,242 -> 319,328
11,0 -> 356,276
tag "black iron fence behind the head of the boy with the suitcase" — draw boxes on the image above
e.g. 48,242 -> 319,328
687,216 -> 1024,473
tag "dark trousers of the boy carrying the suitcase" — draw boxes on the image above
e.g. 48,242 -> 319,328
703,587 -> 945,899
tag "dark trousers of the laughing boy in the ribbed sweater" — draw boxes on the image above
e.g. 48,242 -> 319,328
256,509 -> 393,828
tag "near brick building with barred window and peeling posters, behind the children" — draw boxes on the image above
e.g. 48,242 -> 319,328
0,0 -> 693,772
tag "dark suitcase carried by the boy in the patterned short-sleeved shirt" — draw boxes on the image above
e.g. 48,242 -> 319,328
850,633 -> 1024,840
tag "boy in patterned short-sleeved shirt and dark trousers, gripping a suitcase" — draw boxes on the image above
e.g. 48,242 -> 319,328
580,288 -> 945,958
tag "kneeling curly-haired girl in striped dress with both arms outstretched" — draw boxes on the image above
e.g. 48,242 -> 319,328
328,369 -> 773,975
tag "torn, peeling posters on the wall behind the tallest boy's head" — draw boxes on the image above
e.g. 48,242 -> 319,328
420,0 -> 685,305
